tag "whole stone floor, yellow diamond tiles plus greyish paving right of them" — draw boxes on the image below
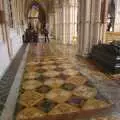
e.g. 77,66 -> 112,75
16,43 -> 120,120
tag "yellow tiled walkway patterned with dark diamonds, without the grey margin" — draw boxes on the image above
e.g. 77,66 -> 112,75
16,45 -> 117,120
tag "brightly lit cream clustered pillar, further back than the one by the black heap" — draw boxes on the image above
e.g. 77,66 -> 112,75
55,0 -> 77,44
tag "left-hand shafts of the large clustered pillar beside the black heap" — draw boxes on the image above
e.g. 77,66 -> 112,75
78,0 -> 91,57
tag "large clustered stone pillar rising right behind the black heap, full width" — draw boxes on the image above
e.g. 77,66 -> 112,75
78,0 -> 101,57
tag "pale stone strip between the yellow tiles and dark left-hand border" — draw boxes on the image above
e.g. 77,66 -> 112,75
0,45 -> 29,120
